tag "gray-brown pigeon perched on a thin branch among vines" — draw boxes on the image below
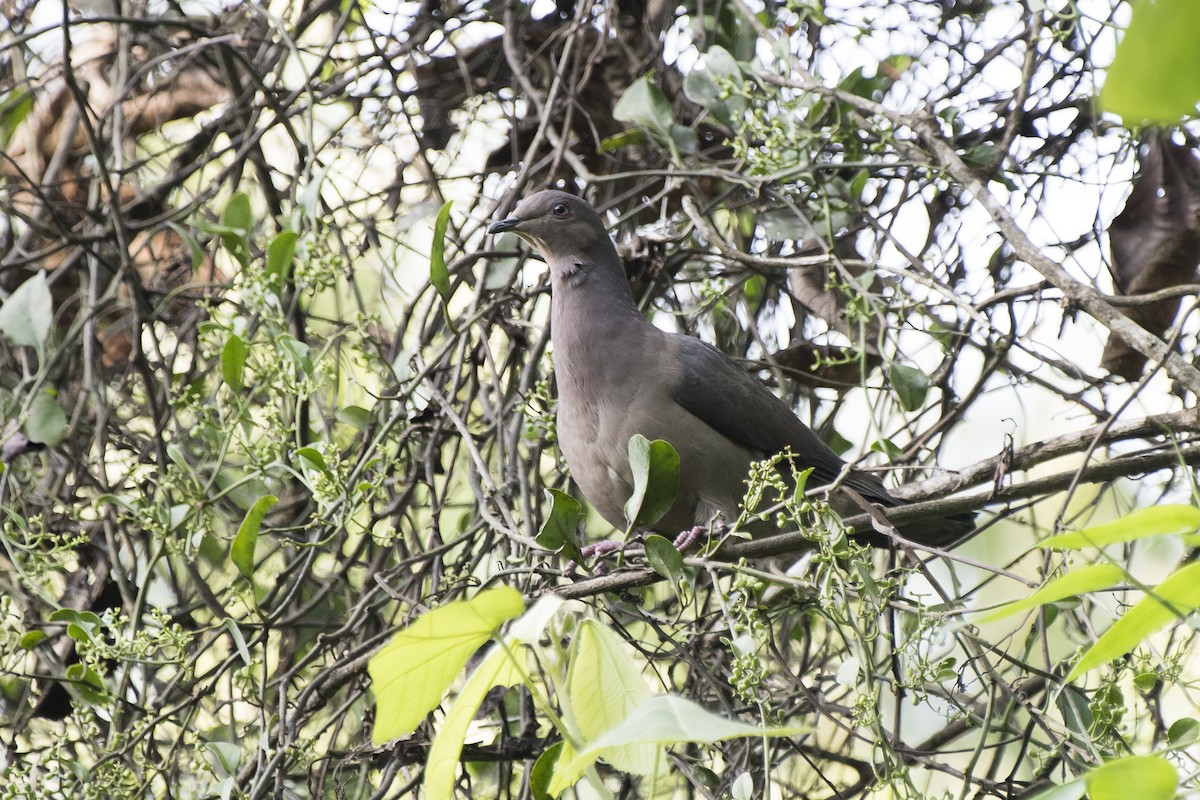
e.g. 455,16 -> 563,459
488,191 -> 973,546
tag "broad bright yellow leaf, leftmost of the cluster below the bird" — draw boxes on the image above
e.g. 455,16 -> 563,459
367,587 -> 524,743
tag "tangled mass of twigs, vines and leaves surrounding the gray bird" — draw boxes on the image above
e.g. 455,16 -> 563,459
0,0 -> 1200,798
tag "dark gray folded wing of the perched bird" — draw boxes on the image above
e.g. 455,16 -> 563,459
672,336 -> 892,503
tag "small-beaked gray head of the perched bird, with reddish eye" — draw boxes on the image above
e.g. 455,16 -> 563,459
487,190 -> 612,263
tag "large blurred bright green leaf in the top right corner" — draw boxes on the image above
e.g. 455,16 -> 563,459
1099,0 -> 1200,127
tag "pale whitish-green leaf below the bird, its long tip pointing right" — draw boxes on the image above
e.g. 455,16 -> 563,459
552,694 -> 809,792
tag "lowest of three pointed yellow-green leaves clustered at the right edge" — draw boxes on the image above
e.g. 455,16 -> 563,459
1066,564 -> 1200,682
